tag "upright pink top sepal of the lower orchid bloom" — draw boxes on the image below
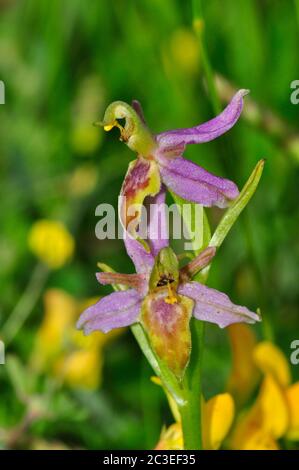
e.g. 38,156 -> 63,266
147,186 -> 169,256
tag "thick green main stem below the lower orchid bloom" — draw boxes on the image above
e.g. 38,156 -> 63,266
179,319 -> 204,450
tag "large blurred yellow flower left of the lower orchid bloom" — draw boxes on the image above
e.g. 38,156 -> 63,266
31,289 -> 122,389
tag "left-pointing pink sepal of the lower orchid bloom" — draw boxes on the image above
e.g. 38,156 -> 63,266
77,289 -> 141,335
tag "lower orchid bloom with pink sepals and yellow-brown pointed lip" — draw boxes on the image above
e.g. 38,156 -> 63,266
77,190 -> 259,378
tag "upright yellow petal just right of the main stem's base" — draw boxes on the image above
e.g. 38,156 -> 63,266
202,393 -> 235,450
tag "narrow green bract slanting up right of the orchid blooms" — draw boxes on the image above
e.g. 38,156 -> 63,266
209,160 -> 265,247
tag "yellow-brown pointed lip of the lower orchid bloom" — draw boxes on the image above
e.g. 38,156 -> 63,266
141,289 -> 193,379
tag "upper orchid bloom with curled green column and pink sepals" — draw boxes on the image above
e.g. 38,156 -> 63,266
100,90 -> 248,236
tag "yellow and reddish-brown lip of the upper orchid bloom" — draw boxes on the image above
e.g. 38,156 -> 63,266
119,157 -> 161,237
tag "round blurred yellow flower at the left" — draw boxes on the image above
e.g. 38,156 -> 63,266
28,219 -> 75,269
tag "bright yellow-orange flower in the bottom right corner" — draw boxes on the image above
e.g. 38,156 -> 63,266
230,326 -> 299,450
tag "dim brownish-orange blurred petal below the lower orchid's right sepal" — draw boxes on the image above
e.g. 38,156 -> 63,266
227,323 -> 259,404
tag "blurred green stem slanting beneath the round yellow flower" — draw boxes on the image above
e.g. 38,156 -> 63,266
2,263 -> 49,346
